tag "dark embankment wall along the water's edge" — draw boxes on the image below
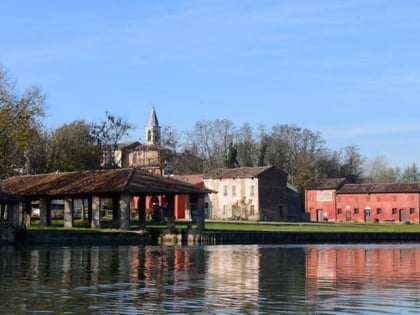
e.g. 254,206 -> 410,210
4,229 -> 420,245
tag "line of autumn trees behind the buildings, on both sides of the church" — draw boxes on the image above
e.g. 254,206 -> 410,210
0,66 -> 420,191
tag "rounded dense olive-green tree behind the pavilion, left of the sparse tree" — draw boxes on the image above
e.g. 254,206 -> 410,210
47,120 -> 102,172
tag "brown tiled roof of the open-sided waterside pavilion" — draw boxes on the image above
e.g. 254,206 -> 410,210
1,168 -> 211,196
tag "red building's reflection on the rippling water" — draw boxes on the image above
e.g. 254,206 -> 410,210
305,246 -> 420,292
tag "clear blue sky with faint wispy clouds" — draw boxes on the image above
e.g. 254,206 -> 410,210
0,0 -> 420,168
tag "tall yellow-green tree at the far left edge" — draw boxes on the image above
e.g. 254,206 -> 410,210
0,66 -> 45,178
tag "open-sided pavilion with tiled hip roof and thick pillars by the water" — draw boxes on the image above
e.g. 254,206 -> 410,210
1,168 -> 212,230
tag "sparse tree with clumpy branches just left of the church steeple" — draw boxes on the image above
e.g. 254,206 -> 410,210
91,112 -> 134,168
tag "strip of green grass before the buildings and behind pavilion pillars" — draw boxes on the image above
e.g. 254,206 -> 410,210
28,218 -> 420,233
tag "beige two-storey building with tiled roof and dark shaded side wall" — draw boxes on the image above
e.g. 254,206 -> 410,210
203,166 -> 288,221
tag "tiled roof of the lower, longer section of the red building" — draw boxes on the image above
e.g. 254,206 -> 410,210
337,183 -> 420,194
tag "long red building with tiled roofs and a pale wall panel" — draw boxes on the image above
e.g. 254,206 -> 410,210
305,178 -> 420,223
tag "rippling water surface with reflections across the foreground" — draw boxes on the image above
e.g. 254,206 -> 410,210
0,245 -> 420,314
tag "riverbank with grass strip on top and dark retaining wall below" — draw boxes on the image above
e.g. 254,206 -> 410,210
4,221 -> 420,245
